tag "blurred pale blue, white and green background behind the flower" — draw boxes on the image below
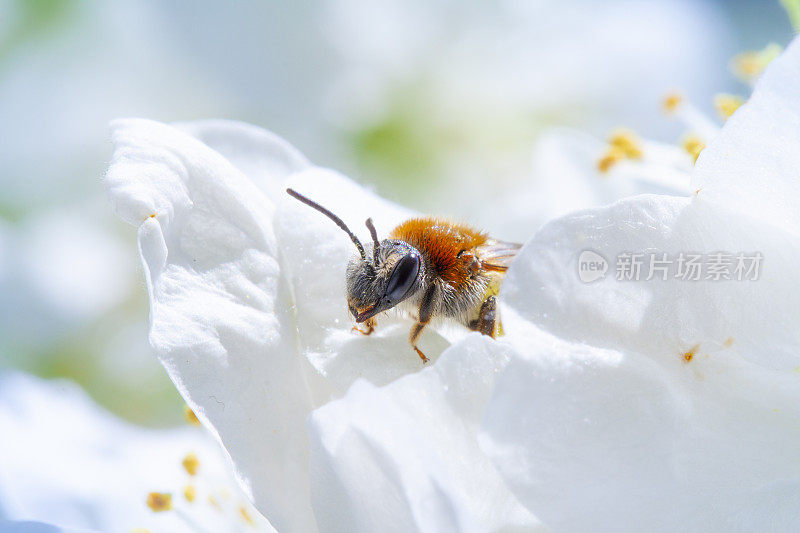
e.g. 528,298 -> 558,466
0,0 -> 792,426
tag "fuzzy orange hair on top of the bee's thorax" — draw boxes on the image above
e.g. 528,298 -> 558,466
389,217 -> 488,286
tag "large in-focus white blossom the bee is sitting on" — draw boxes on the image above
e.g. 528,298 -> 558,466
105,36 -> 800,531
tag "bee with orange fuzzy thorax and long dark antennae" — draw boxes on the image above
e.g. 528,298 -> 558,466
286,189 -> 521,363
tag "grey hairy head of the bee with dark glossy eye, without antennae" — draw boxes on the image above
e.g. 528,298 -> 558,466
347,240 -> 423,322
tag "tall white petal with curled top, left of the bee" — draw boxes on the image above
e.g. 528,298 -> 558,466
106,120 -> 316,530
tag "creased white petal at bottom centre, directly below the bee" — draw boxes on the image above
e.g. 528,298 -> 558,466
309,334 -> 540,532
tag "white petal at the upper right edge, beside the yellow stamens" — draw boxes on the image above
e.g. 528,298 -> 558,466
692,39 -> 800,239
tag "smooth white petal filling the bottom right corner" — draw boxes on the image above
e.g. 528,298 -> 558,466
480,314 -> 800,531
